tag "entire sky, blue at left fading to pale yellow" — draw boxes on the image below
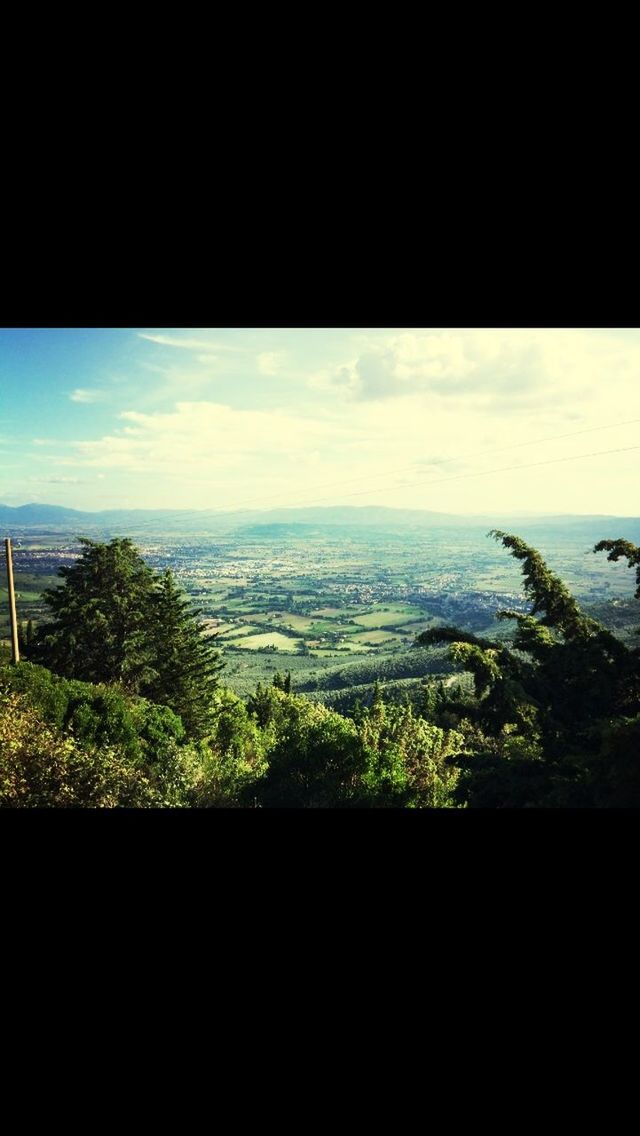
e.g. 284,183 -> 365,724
0,328 -> 640,516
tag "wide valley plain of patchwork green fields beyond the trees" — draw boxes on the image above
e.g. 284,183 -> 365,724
7,526 -> 640,695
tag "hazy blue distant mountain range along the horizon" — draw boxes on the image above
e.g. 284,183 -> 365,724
0,503 -> 640,538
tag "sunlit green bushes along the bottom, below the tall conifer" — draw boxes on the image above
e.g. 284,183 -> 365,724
0,661 -> 459,808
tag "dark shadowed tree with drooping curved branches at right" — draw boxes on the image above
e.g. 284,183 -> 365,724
417,531 -> 640,808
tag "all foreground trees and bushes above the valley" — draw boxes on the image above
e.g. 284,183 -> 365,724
0,532 -> 640,809
